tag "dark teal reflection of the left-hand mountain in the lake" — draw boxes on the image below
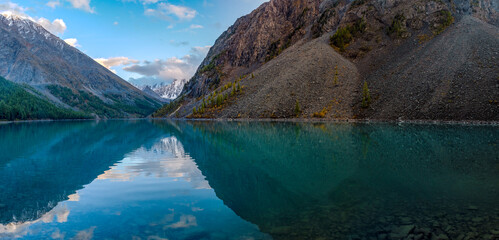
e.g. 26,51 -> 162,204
0,121 -> 166,224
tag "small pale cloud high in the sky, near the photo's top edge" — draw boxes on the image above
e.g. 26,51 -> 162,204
144,3 -> 197,21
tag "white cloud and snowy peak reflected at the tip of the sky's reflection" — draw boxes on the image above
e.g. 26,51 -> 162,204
98,137 -> 210,189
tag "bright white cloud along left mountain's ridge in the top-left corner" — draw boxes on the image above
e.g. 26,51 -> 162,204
0,2 -> 67,34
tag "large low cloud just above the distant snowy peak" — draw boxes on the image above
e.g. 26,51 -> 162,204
123,46 -> 210,81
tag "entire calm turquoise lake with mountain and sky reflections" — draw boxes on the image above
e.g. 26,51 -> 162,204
0,120 -> 499,239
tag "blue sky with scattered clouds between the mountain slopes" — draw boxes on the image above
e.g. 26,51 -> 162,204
0,0 -> 266,85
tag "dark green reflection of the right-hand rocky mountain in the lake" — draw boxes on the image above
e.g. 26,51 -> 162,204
155,122 -> 499,239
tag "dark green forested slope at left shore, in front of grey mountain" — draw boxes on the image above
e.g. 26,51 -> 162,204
0,77 -> 90,121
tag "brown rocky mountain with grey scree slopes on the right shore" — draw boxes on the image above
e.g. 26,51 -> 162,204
155,0 -> 499,121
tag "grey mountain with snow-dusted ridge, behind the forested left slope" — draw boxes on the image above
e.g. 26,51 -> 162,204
0,15 -> 161,118
